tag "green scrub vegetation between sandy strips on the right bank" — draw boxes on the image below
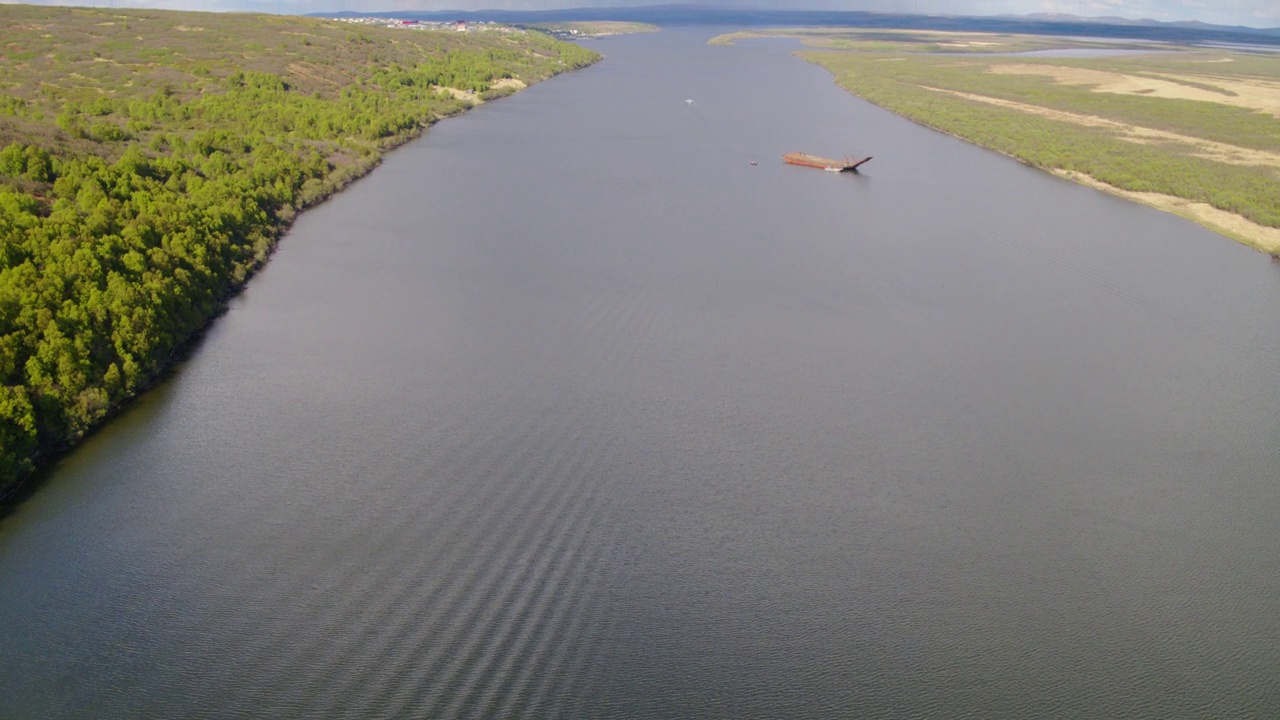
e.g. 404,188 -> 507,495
804,53 -> 1280,227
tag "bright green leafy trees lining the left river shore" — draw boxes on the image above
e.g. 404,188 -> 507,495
0,11 -> 599,489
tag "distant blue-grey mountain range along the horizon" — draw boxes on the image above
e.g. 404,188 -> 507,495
316,5 -> 1280,47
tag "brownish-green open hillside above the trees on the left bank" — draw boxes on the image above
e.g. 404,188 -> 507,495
0,5 -> 588,161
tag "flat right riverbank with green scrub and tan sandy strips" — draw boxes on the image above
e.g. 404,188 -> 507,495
713,29 -> 1280,256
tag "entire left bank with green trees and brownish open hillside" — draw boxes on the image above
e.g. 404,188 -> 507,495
0,5 -> 599,491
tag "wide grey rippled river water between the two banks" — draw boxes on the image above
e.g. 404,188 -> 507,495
0,29 -> 1280,720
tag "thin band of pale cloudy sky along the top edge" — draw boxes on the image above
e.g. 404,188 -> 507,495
0,0 -> 1280,27
